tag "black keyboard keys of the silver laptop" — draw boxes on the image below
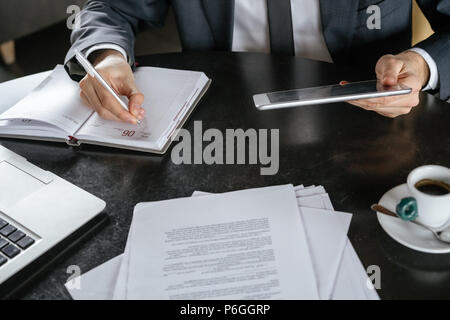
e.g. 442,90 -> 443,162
0,218 -> 34,266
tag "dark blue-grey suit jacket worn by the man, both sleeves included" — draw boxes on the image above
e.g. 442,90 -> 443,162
65,0 -> 450,100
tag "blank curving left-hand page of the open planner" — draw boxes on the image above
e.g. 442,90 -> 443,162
0,65 -> 93,135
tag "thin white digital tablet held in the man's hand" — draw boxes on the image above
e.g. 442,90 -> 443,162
253,80 -> 412,110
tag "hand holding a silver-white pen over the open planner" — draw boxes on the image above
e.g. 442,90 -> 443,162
75,50 -> 145,124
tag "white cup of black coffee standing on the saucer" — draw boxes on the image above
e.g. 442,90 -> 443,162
407,165 -> 450,228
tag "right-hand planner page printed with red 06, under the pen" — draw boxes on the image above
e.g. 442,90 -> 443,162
75,67 -> 208,149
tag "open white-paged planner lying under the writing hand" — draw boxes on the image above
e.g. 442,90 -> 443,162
0,65 -> 211,153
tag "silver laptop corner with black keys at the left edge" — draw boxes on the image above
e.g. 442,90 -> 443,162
0,145 -> 105,292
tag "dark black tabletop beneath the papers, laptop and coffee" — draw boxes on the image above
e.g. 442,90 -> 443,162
0,52 -> 450,299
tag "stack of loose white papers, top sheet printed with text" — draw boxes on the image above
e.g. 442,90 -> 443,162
66,185 -> 378,300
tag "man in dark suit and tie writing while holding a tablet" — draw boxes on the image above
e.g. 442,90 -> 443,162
65,0 -> 450,123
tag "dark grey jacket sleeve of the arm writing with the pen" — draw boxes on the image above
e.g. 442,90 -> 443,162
64,0 -> 169,80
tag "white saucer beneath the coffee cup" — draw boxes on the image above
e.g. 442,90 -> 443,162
377,183 -> 450,253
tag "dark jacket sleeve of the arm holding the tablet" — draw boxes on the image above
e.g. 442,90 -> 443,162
416,0 -> 450,100
